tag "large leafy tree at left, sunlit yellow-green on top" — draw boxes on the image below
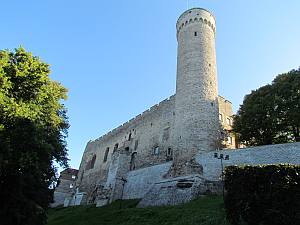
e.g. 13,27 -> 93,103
0,47 -> 69,225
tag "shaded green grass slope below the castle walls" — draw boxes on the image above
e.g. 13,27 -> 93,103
47,196 -> 229,225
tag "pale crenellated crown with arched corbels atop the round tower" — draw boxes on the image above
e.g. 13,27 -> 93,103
176,8 -> 216,34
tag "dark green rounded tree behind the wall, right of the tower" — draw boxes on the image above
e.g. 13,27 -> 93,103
233,69 -> 300,146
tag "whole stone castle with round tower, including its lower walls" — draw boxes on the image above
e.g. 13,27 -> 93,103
54,8 -> 299,206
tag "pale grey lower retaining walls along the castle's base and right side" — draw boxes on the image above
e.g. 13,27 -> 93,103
116,143 -> 300,206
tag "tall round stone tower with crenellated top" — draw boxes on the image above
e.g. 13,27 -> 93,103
174,8 -> 219,160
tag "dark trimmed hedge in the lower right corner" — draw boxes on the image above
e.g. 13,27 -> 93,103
225,165 -> 300,225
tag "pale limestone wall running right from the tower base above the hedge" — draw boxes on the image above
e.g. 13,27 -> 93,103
196,143 -> 300,180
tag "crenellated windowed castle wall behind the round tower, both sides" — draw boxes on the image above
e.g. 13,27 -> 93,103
77,95 -> 234,193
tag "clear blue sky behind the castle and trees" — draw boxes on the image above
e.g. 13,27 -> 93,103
0,0 -> 300,168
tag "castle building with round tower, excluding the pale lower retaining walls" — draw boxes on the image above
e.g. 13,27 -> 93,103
62,8 -> 235,206
